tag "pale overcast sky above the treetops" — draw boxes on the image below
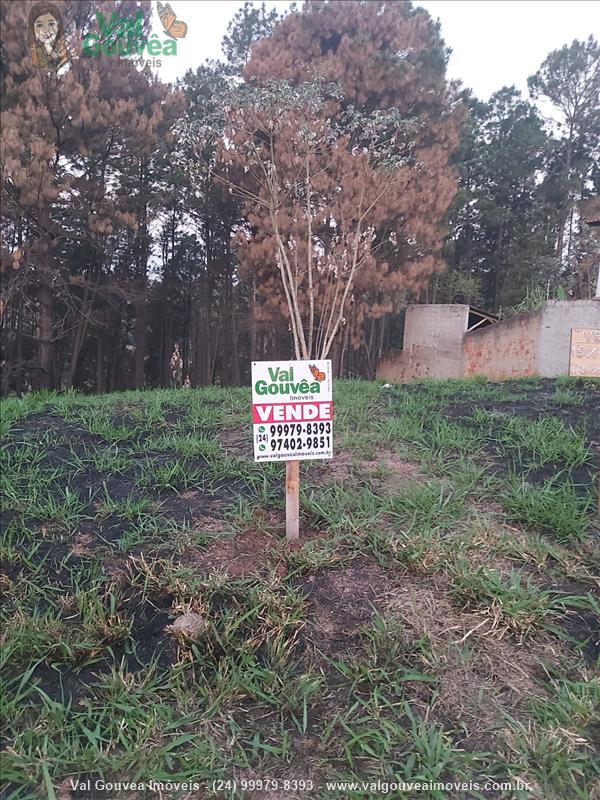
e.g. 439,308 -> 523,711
153,0 -> 600,100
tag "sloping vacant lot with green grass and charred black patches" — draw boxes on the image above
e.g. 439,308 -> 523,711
0,380 -> 600,800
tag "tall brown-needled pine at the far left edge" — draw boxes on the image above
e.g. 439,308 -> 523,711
2,0 -> 177,388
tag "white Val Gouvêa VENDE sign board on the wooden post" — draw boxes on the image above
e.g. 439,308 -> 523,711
252,361 -> 333,461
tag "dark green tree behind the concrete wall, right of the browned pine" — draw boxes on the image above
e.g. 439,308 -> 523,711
443,87 -> 552,311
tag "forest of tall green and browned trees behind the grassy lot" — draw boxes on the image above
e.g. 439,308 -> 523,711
0,0 -> 600,394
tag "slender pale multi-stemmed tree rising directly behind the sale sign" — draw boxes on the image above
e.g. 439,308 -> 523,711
217,81 -> 422,359
